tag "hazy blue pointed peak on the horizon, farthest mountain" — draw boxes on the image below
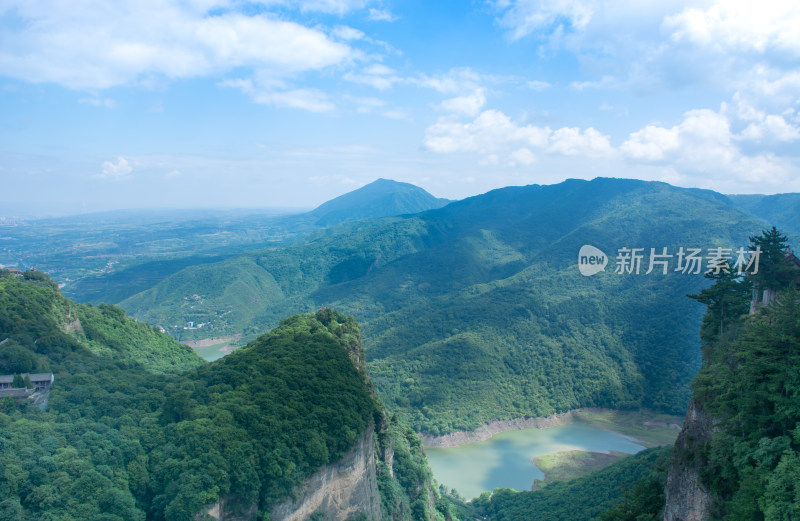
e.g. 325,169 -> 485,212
310,177 -> 450,226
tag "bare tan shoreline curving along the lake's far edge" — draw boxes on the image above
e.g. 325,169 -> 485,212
419,407 -> 682,448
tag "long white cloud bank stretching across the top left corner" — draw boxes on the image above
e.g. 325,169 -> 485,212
0,0 -> 354,89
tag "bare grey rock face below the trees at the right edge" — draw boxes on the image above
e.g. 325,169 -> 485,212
664,399 -> 714,521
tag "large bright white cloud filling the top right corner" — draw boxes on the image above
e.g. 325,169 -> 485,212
491,0 -> 800,103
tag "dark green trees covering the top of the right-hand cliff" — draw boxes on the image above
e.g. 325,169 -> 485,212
677,228 -> 800,521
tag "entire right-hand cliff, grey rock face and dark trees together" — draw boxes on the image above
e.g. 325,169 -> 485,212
664,228 -> 800,521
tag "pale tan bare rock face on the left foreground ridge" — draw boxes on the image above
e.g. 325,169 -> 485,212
272,426 -> 381,521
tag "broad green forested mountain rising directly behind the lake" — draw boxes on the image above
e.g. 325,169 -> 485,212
122,179 -> 762,434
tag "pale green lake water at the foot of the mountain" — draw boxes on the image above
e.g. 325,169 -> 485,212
425,424 -> 644,499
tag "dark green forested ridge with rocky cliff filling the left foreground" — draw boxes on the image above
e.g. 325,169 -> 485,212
0,271 -> 456,521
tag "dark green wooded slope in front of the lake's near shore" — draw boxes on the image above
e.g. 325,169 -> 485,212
471,447 -> 672,521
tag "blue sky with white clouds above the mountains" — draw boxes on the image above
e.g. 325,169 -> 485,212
0,0 -> 800,216
